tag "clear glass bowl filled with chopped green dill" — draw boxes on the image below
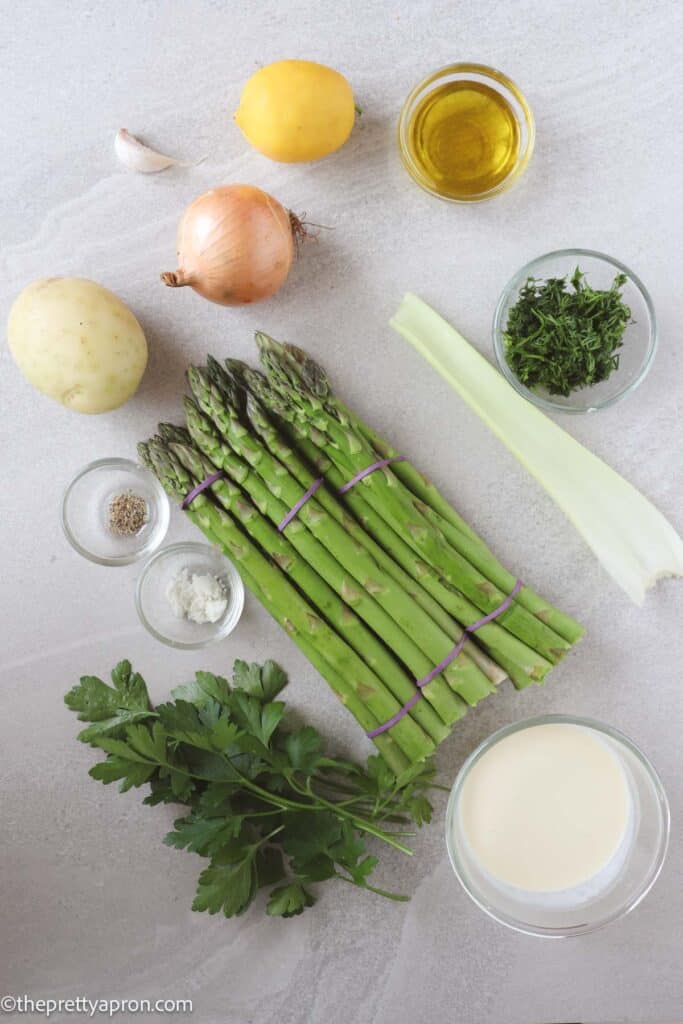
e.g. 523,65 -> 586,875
493,249 -> 657,413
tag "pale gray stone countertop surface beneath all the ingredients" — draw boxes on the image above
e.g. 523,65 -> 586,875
0,0 -> 683,1024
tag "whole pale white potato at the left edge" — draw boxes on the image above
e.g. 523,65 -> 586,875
7,278 -> 147,413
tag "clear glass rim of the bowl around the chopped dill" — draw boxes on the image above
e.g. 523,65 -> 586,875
492,248 -> 659,416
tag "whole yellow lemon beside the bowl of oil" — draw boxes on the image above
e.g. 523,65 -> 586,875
234,60 -> 355,164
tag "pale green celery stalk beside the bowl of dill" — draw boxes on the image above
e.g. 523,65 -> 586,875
391,293 -> 683,604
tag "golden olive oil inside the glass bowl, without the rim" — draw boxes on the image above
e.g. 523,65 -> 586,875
408,79 -> 521,201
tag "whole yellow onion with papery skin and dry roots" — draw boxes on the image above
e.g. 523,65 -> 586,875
161,184 -> 305,306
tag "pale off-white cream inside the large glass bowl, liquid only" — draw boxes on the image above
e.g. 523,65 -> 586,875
454,723 -> 633,898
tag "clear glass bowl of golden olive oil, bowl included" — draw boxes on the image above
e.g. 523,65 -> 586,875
398,63 -> 535,203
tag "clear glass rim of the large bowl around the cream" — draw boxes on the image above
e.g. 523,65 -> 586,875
445,714 -> 671,939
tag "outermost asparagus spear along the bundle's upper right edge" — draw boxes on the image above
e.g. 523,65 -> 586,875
256,332 -> 583,644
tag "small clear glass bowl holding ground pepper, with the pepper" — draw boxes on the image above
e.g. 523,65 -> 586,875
61,459 -> 170,565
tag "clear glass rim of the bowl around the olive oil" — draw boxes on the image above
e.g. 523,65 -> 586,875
398,60 -> 536,206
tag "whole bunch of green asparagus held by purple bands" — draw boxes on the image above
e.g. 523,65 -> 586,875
138,334 -> 582,776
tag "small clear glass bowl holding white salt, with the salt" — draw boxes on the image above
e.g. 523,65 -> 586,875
135,541 -> 245,650
